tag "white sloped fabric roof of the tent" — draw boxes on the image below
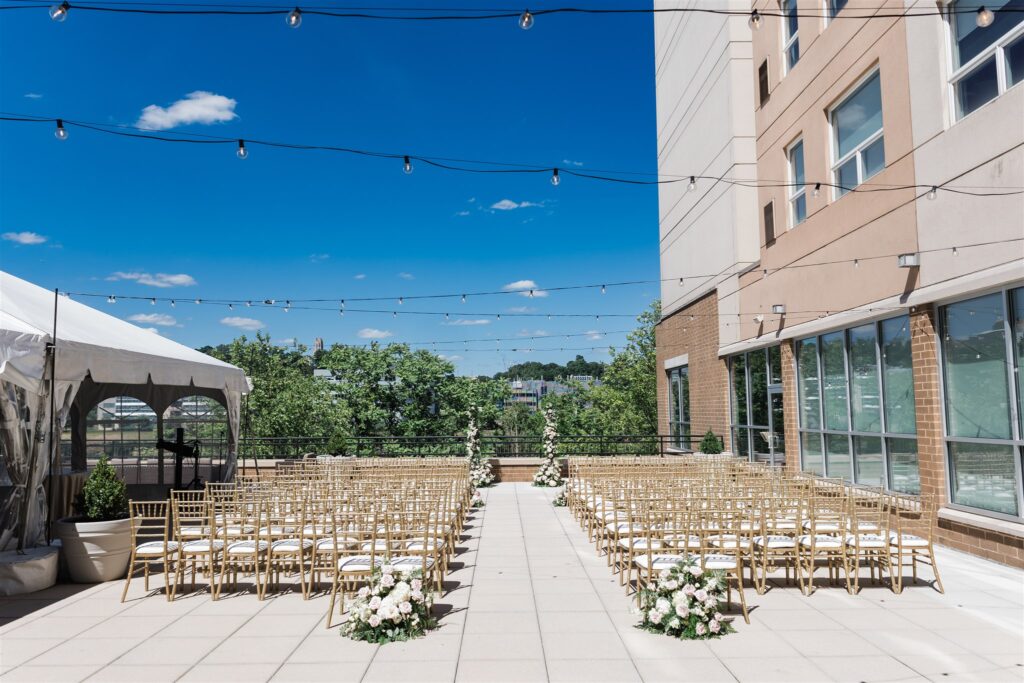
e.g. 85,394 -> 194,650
0,271 -> 248,393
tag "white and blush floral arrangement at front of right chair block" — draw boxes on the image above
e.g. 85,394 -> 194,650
639,555 -> 733,640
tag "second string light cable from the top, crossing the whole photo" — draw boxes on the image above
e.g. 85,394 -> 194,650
0,112 -> 1024,198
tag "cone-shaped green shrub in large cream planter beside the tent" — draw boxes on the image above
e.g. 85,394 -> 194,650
53,456 -> 131,584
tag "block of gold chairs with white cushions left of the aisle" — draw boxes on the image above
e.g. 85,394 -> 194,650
122,459 -> 472,627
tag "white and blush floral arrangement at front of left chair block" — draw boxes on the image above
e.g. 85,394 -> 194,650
341,564 -> 434,644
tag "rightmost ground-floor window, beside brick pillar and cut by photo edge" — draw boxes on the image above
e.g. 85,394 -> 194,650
939,287 -> 1024,518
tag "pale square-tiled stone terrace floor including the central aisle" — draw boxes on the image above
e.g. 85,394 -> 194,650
0,484 -> 1024,683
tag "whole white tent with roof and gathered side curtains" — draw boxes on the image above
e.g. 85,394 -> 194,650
0,271 -> 248,550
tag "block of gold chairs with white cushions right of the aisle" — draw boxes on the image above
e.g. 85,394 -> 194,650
566,457 -> 943,621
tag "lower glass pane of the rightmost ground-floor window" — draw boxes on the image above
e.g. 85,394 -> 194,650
949,441 -> 1018,515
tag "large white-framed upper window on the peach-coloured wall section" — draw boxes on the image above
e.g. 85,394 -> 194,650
829,72 -> 886,197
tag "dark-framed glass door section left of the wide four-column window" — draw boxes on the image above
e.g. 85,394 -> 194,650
729,346 -> 785,465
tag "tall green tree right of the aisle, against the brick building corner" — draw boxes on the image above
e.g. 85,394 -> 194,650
543,301 -> 662,435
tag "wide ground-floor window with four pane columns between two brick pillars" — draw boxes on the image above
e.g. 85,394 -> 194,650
796,315 -> 921,494
